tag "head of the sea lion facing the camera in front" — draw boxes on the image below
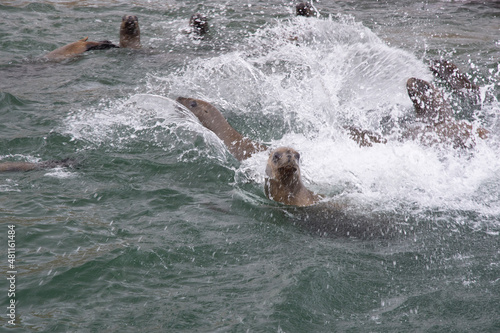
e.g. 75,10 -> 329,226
266,147 -> 300,180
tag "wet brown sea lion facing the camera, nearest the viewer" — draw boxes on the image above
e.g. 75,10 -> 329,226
264,147 -> 321,207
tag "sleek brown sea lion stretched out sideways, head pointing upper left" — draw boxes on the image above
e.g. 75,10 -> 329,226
177,97 -> 267,161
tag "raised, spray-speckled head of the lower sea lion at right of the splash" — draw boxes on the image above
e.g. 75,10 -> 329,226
406,78 -> 452,123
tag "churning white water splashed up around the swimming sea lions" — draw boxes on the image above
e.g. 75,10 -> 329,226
65,16 -> 500,224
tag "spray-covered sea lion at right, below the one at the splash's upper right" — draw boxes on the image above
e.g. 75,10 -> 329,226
404,78 -> 488,148
